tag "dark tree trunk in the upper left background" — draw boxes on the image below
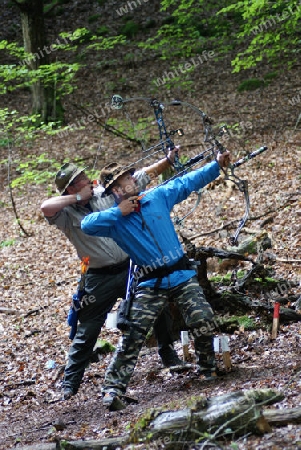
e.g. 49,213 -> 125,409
16,0 -> 55,123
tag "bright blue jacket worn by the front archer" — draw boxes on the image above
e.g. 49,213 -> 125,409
81,161 -> 220,289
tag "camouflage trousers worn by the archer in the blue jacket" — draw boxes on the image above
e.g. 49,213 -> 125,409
102,277 -> 215,395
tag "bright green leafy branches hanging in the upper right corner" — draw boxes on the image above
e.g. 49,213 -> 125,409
140,0 -> 301,72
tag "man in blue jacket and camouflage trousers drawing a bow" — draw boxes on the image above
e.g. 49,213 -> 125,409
81,152 -> 229,410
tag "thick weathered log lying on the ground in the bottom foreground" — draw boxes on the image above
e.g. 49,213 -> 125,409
148,389 -> 284,440
